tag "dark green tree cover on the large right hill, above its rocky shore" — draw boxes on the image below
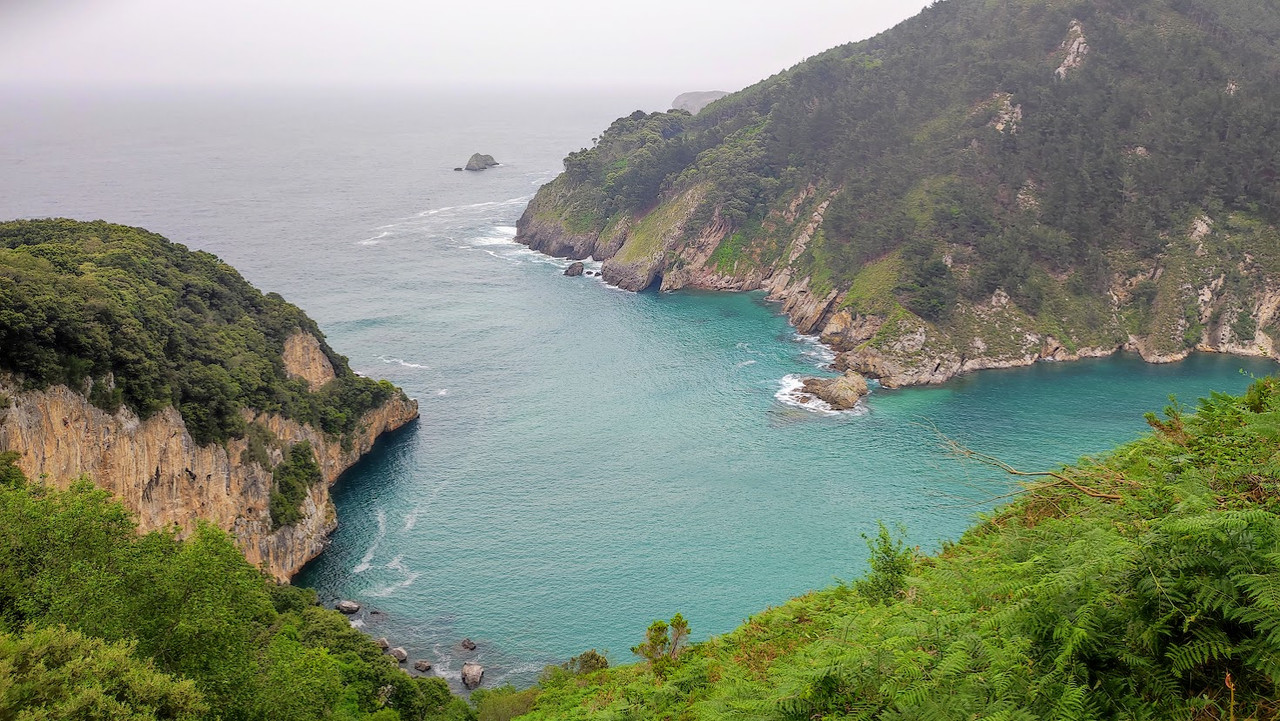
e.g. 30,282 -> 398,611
535,0 -> 1280,343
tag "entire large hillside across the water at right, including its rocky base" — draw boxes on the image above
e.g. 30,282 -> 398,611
518,0 -> 1280,385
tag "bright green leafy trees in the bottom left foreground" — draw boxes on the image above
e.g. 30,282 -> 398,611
0,457 -> 472,721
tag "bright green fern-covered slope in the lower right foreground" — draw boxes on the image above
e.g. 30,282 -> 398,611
514,378 -> 1280,721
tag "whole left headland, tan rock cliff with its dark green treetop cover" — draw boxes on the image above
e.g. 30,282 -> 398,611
0,220 -> 417,580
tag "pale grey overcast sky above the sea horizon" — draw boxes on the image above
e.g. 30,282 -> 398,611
0,0 -> 924,90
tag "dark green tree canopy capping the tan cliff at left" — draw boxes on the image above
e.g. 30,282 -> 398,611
0,220 -> 396,444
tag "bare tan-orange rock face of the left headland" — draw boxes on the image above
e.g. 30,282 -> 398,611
0,371 -> 417,581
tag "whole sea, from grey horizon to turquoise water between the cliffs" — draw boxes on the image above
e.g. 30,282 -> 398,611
0,88 -> 1275,689
